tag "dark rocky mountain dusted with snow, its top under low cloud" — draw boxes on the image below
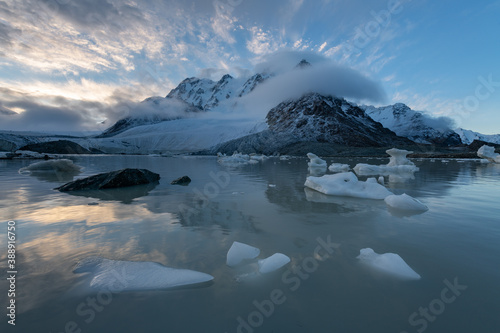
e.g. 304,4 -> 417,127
267,93 -> 412,147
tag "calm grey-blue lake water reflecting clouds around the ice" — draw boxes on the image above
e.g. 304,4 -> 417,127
0,156 -> 500,333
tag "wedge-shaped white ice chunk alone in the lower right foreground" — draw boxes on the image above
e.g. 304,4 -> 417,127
357,248 -> 420,280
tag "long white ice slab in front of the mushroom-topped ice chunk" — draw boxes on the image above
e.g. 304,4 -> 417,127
304,172 -> 392,199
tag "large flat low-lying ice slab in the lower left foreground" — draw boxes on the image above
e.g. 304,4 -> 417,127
74,257 -> 213,291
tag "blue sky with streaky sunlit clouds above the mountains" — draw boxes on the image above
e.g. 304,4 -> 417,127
0,0 -> 500,134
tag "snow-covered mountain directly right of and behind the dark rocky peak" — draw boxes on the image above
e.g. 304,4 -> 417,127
360,103 -> 462,146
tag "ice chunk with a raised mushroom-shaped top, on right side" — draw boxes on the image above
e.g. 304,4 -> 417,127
353,148 -> 419,182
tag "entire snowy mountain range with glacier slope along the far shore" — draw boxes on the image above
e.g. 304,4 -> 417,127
0,60 -> 500,153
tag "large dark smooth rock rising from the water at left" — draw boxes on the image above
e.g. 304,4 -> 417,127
55,169 -> 160,192
